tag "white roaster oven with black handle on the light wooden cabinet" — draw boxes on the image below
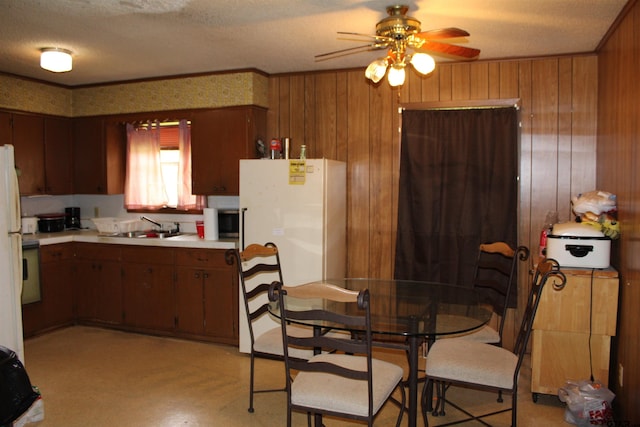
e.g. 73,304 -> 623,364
546,222 -> 611,268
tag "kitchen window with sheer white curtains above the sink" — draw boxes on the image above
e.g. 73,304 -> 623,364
125,120 -> 205,211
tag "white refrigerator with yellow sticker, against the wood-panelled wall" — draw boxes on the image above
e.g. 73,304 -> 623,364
239,159 -> 347,353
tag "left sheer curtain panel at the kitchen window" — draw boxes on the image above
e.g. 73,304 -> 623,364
124,122 -> 168,209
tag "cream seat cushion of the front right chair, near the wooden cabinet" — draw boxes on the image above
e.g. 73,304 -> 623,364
426,339 -> 518,390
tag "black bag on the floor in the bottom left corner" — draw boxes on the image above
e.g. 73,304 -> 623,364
0,346 -> 40,426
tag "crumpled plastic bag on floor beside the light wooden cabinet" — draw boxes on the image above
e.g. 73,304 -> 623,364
558,381 -> 616,427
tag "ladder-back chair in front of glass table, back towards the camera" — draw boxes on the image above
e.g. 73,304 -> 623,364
269,282 -> 405,427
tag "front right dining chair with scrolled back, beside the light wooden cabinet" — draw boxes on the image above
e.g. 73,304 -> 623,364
425,259 -> 566,427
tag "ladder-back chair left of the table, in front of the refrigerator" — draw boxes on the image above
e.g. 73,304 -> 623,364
226,242 -> 313,412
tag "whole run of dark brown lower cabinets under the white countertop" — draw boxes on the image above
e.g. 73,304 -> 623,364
23,242 -> 238,345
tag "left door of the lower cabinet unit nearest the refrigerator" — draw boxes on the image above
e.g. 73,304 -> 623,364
176,266 -> 206,335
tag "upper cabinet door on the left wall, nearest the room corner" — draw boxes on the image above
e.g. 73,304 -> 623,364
44,117 -> 73,194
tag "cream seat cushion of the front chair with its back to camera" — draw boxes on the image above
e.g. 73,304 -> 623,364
291,353 -> 404,417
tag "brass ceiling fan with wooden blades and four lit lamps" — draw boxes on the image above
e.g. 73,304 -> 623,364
316,5 -> 480,86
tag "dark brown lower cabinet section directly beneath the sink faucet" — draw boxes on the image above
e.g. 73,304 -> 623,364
122,246 -> 175,331
